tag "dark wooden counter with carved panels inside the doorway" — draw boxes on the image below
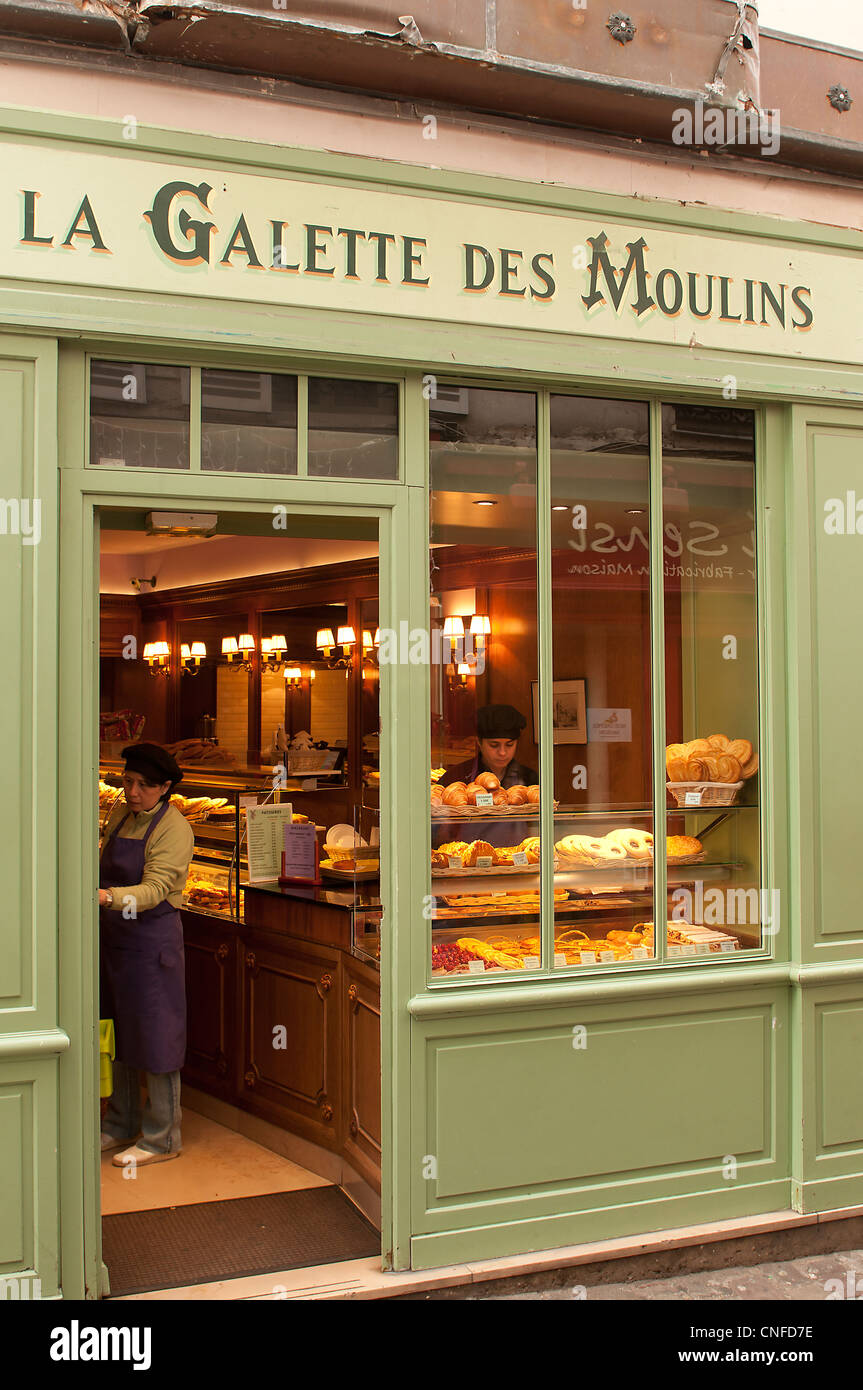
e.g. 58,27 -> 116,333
182,884 -> 381,1193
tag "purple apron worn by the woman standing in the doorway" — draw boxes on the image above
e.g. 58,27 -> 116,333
99,802 -> 186,1073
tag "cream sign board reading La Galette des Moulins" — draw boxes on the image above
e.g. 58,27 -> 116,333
0,138 -> 863,363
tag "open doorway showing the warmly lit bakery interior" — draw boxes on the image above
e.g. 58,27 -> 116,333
94,502 -> 384,1295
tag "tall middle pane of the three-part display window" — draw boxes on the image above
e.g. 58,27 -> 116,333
550,396 -> 653,967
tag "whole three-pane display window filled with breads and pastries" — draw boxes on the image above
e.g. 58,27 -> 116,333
428,386 -> 755,981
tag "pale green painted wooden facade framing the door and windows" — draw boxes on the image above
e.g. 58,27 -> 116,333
0,111 -> 863,1298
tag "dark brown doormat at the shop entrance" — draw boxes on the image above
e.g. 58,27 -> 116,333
101,1187 -> 381,1297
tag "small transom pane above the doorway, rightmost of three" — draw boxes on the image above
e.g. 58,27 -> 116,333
309,377 -> 399,478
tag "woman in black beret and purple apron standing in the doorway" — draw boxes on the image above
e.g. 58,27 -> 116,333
99,744 -> 195,1166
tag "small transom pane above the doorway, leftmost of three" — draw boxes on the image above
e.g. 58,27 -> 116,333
90,361 -> 190,468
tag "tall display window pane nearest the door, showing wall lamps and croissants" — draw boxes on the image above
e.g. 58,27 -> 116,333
429,384 -> 541,979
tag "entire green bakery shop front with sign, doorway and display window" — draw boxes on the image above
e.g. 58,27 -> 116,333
0,102 -> 863,1297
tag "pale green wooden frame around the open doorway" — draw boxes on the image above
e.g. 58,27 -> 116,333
58,458 -> 428,1297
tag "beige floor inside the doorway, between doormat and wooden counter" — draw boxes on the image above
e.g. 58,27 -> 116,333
101,1108 -> 329,1216
